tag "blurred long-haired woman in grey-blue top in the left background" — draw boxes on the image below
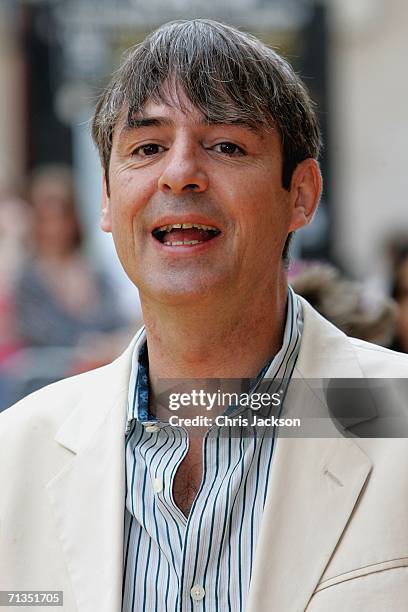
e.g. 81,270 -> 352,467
15,165 -> 127,365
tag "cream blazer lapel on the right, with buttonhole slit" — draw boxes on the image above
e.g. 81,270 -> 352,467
247,300 -> 372,612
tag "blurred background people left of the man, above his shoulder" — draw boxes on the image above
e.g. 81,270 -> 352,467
0,166 -> 140,410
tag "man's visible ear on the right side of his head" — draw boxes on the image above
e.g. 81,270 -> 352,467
289,158 -> 323,232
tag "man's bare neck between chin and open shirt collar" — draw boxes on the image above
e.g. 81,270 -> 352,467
141,271 -> 287,388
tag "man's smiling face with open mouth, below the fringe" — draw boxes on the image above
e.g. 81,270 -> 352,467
102,91 -> 310,304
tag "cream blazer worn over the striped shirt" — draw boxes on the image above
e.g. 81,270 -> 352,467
0,301 -> 408,612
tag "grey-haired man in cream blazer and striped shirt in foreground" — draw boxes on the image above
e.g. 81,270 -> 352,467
0,20 -> 408,612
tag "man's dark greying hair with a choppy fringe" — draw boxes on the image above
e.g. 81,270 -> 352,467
92,19 -> 321,254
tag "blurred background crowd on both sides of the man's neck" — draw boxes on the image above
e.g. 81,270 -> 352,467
0,166 -> 408,410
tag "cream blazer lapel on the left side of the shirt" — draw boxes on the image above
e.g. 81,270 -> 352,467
47,343 -> 134,612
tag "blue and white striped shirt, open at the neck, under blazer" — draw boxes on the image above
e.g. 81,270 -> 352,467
122,288 -> 303,612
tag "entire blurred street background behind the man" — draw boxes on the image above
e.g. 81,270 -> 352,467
0,0 -> 408,410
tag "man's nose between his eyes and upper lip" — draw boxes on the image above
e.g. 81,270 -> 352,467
158,143 -> 208,195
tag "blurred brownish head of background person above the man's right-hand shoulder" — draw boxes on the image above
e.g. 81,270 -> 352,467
290,262 -> 396,347
